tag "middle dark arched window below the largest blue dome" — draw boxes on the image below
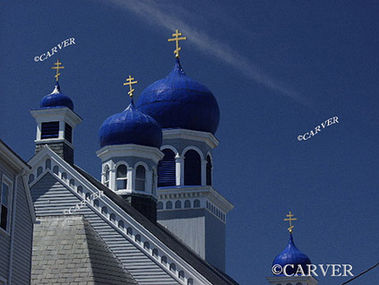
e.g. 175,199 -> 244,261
184,149 -> 201,185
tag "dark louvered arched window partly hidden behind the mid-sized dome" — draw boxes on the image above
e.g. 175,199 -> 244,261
158,149 -> 176,187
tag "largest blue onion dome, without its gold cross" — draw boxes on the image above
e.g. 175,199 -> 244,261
136,59 -> 220,134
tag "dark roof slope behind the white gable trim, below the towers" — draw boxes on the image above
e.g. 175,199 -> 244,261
73,165 -> 238,285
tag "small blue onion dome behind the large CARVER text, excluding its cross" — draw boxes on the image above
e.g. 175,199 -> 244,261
272,234 -> 311,275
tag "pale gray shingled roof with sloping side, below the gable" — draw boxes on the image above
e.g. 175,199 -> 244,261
31,215 -> 137,285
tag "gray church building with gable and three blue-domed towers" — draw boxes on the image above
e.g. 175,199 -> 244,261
28,31 -> 237,285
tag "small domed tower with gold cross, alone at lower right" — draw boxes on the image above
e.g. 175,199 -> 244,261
267,211 -> 318,285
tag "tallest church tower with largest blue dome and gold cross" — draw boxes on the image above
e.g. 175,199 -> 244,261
136,30 -> 233,271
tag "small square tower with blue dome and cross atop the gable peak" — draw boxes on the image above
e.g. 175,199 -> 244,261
30,60 -> 82,164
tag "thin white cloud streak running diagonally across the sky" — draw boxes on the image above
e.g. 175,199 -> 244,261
107,0 -> 310,106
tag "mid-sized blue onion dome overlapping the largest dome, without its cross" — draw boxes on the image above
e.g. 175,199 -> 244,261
99,101 -> 162,148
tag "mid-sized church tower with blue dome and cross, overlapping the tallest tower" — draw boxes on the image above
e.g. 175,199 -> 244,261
97,76 -> 163,222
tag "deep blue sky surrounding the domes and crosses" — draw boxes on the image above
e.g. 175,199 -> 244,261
0,0 -> 379,285
